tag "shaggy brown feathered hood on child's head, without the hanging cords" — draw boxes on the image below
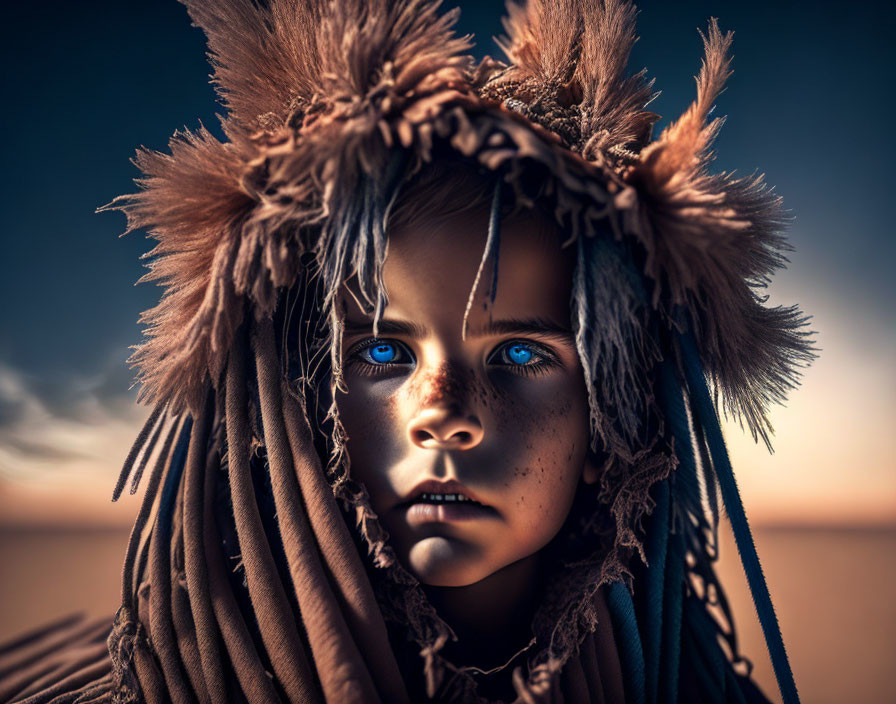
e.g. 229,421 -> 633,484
107,0 -> 810,441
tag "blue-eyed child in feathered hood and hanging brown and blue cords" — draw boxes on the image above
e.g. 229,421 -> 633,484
0,0 -> 811,702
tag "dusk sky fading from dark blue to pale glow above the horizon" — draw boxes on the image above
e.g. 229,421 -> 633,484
0,0 -> 896,524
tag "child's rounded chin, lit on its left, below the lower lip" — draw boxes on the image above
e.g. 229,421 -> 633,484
404,537 -> 494,587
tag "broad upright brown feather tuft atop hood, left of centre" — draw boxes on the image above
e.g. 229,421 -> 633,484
182,0 -> 470,129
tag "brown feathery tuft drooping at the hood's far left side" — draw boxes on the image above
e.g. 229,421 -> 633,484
100,128 -> 255,410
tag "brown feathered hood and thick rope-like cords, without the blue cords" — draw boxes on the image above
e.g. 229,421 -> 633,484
0,0 -> 812,704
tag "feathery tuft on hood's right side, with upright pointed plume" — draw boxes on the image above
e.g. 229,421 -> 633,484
624,19 -> 814,444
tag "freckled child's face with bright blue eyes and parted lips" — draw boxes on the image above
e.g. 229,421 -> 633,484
337,206 -> 595,586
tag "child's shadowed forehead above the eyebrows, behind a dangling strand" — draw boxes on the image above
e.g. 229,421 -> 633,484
356,209 -> 574,335
